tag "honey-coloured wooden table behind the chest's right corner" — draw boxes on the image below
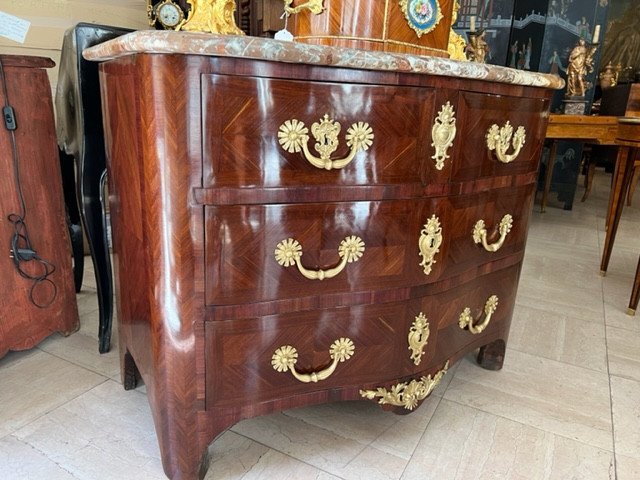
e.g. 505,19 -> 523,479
540,114 -> 618,213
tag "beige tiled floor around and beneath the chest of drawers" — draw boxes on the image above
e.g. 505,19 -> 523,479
0,172 -> 640,480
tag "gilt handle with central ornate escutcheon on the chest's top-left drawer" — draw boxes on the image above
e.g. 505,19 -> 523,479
278,114 -> 374,170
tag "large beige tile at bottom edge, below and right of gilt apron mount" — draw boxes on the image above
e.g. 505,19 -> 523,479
402,399 -> 613,480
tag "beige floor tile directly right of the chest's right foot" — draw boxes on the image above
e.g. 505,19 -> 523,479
509,304 -> 607,372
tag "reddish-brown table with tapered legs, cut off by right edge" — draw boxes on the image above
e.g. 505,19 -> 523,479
600,117 -> 640,315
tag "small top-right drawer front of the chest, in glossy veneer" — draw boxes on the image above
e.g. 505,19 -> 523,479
451,92 -> 548,181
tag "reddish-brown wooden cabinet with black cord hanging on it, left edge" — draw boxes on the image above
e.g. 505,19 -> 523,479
0,55 -> 79,357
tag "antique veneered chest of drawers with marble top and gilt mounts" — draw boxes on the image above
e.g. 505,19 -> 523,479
85,32 -> 561,479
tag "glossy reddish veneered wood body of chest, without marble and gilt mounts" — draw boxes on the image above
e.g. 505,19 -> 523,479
101,50 -> 549,479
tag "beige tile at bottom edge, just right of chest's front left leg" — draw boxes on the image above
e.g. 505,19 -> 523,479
205,431 -> 340,480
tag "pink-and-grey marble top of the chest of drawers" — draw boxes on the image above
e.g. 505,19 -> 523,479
83,30 -> 564,89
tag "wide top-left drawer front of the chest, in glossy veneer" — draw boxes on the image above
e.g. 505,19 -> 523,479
202,75 -> 438,187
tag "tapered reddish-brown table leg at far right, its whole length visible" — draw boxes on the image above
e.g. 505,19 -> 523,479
600,147 -> 633,276
